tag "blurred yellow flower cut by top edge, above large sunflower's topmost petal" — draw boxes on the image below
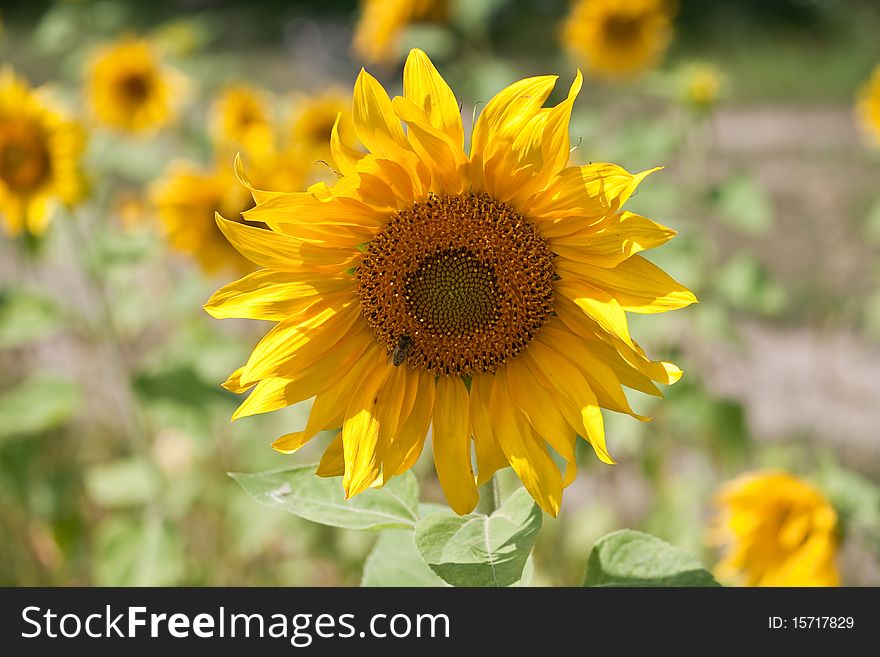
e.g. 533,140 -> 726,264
352,0 -> 449,64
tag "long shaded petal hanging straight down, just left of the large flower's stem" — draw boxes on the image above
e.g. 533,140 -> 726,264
433,376 -> 479,515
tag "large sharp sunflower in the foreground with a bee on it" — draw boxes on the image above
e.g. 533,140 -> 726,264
205,50 -> 695,515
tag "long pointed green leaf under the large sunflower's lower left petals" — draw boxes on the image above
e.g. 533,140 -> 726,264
229,465 -> 419,529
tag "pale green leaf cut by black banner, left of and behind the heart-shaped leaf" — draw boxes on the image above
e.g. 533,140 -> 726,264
361,529 -> 449,586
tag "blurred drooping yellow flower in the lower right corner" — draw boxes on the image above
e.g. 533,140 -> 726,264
714,470 -> 840,586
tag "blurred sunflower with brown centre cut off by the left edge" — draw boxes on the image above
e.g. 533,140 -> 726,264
0,67 -> 85,235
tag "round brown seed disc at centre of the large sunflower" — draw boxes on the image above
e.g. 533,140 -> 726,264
356,194 -> 555,376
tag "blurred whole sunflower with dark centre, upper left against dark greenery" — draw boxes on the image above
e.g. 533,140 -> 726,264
86,39 -> 184,133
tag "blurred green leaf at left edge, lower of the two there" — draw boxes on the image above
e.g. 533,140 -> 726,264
0,373 -> 80,441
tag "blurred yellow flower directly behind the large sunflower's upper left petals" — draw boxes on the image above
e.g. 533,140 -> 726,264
150,163 -> 254,274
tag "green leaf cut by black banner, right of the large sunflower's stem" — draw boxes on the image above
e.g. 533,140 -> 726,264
584,529 -> 719,586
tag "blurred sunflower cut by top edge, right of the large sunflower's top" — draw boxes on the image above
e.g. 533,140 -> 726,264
562,0 -> 672,78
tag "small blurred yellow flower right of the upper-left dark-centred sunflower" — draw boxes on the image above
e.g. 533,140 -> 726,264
211,84 -> 274,153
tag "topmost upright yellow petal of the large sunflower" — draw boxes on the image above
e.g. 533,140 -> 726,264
403,48 -> 464,150
